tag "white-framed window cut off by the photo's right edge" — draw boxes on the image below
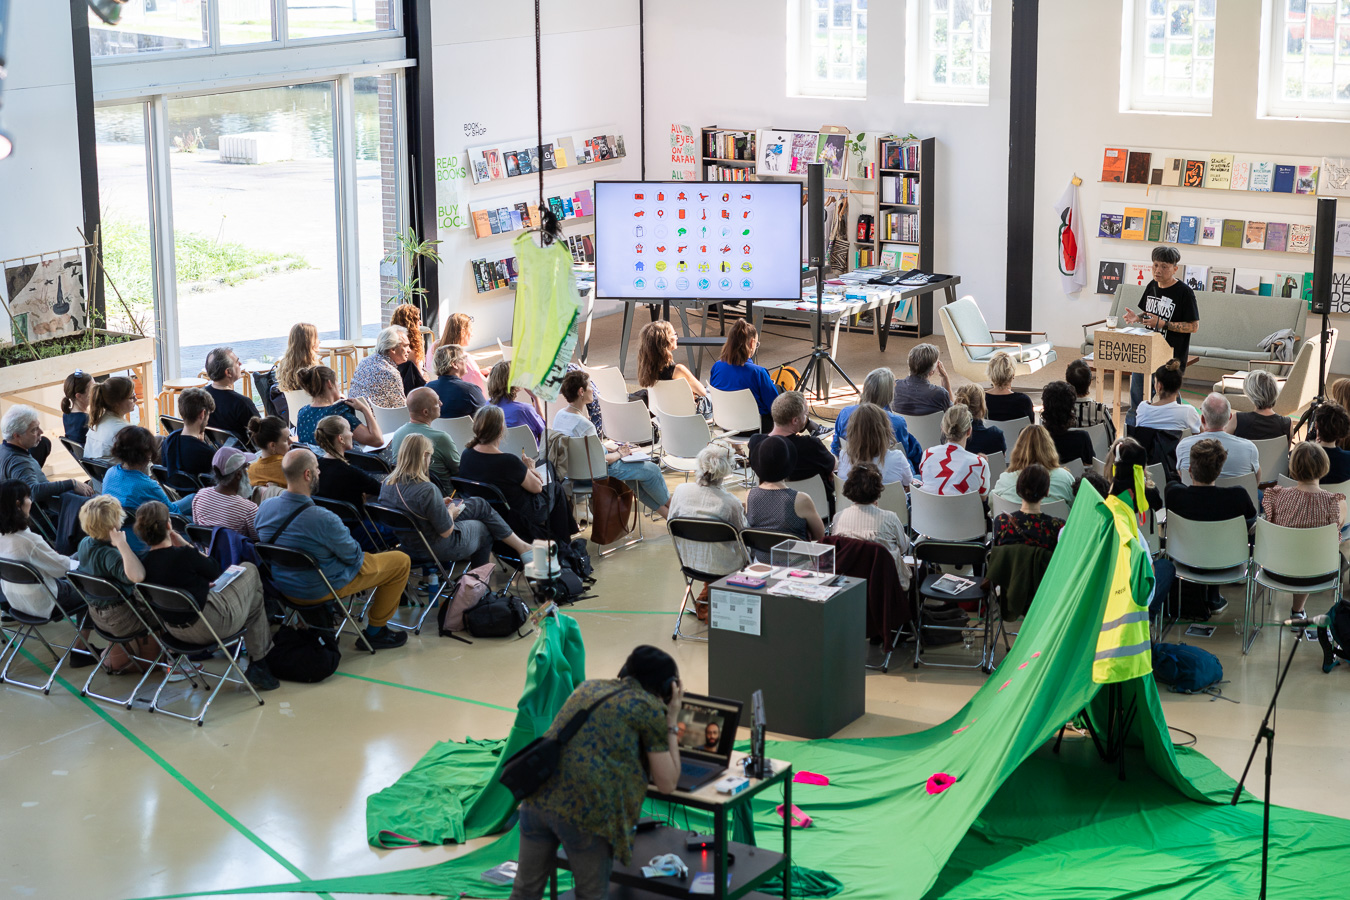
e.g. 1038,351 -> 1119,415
1265,0 -> 1350,119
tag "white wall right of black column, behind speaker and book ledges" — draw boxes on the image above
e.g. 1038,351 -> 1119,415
1033,0 -> 1350,372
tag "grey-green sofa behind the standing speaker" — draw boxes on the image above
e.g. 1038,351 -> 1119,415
1083,285 -> 1308,371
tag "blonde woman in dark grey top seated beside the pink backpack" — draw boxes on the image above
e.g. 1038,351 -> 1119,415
379,434 -> 533,568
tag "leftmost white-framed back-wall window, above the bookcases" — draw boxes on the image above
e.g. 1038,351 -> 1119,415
787,0 -> 867,97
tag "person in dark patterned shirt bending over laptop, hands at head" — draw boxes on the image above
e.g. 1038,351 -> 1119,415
510,645 -> 684,900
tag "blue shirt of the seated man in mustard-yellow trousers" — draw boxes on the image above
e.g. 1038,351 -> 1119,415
254,491 -> 366,600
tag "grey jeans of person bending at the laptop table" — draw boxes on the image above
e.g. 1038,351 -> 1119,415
510,806 -> 614,900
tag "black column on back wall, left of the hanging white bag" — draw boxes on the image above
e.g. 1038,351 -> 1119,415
1004,0 -> 1041,334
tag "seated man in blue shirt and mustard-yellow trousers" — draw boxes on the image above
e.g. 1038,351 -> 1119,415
254,448 -> 412,650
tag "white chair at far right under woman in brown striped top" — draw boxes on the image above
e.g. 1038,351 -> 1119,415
1242,518 -> 1341,653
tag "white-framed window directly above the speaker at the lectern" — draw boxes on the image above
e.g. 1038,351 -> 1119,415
1121,0 -> 1218,113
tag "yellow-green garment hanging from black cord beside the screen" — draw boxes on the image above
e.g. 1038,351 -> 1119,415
510,233 -> 581,401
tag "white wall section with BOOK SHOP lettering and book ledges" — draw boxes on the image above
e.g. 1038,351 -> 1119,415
432,0 -> 651,345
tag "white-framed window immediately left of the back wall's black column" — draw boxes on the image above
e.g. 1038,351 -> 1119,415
906,0 -> 994,104
